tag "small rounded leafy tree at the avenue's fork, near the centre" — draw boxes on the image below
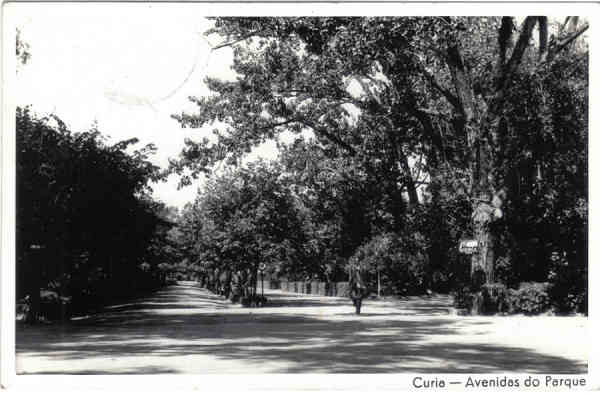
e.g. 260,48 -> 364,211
180,161 -> 305,285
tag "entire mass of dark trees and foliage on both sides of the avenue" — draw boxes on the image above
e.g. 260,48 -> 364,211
16,16 -> 589,314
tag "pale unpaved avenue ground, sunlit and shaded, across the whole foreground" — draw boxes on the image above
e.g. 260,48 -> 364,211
16,282 -> 590,374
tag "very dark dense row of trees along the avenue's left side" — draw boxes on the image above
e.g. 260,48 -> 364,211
16,108 -> 177,318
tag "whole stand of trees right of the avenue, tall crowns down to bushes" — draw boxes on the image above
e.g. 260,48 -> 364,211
171,17 -> 588,308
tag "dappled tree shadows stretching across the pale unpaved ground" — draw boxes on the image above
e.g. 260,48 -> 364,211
16,280 -> 587,374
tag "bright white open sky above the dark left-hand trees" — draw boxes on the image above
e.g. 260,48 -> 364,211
9,3 -> 276,207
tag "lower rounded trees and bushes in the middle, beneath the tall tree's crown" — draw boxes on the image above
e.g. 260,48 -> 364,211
173,153 -> 469,294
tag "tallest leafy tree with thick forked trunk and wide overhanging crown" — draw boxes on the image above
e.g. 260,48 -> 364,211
173,16 -> 588,290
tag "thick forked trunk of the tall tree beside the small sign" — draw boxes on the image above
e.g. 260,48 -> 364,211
445,16 -> 588,313
